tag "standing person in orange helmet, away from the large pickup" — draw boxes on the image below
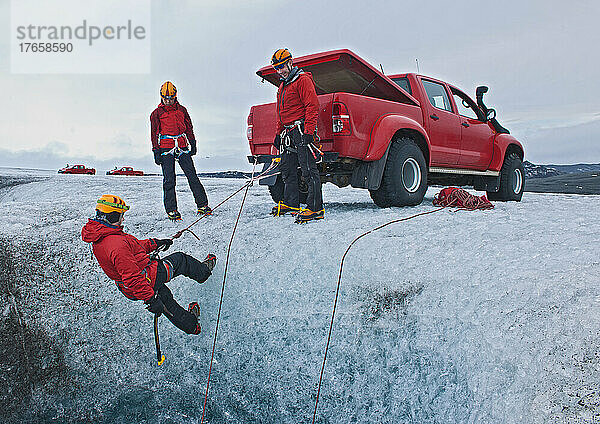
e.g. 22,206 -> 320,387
150,81 -> 212,221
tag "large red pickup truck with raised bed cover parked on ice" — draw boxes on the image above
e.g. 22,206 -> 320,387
247,49 -> 525,207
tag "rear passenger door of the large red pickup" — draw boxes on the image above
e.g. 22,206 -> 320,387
421,78 -> 461,166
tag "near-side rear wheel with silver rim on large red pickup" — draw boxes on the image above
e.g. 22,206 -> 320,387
369,137 -> 427,208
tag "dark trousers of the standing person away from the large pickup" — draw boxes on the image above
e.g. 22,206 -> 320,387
160,149 -> 208,212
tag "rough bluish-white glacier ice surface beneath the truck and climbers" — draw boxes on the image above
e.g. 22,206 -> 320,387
0,174 -> 600,423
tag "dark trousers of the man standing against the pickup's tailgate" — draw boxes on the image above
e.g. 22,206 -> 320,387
280,128 -> 323,212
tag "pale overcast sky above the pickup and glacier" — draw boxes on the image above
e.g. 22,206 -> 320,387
0,0 -> 600,172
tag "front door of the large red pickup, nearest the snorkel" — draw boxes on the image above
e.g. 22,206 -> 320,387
450,87 -> 494,171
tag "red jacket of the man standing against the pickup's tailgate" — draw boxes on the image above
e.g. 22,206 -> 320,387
277,70 -> 319,134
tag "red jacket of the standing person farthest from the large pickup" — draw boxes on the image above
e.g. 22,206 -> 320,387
150,100 -> 196,150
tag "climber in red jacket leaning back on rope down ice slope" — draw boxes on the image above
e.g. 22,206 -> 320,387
81,194 -> 217,334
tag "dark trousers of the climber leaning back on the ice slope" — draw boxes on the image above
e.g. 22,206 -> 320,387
154,252 -> 211,334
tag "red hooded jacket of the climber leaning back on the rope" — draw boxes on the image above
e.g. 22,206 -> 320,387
81,219 -> 158,300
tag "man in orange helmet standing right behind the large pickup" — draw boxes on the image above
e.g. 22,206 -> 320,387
271,49 -> 325,222
